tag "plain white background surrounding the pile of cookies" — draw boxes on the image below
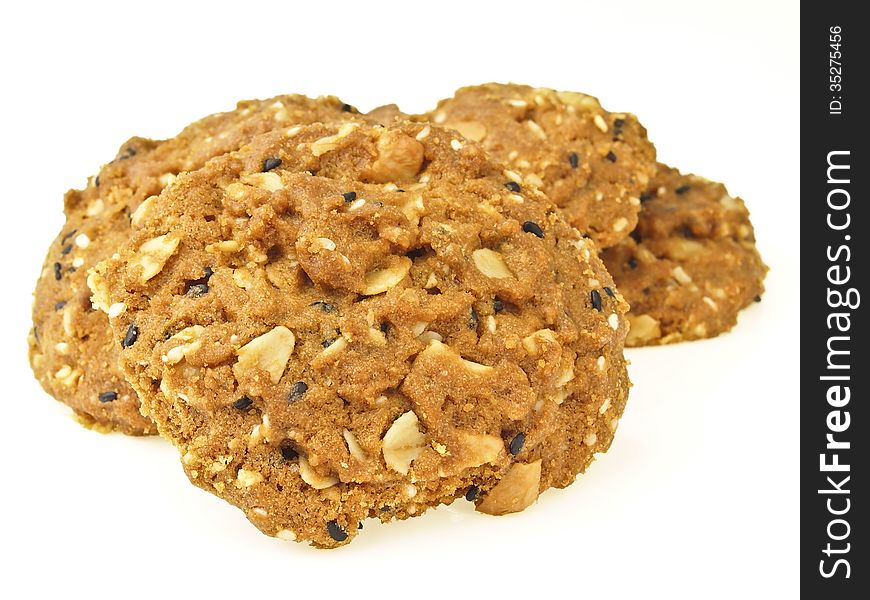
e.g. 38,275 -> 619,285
0,0 -> 800,599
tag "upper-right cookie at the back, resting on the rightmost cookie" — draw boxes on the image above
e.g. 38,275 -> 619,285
426,83 -> 655,248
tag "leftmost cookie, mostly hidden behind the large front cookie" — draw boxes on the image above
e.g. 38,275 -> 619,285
29,95 -> 353,434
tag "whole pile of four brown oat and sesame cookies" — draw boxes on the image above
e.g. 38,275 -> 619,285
30,84 -> 766,548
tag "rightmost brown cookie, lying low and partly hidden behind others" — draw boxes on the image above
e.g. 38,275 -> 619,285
602,165 -> 767,346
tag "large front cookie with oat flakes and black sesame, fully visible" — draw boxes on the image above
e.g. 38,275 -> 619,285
89,122 -> 629,548
